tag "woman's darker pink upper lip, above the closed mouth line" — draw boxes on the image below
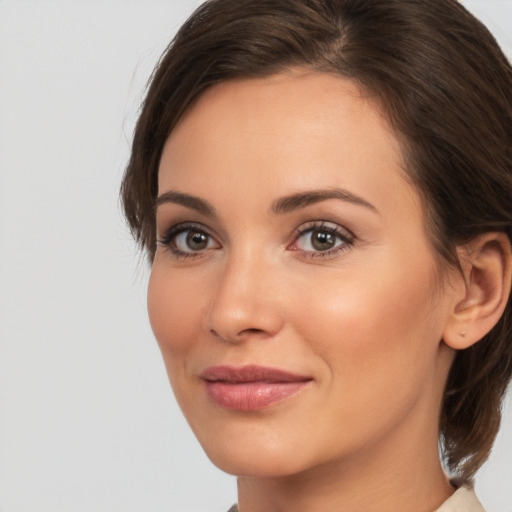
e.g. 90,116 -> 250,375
200,365 -> 312,384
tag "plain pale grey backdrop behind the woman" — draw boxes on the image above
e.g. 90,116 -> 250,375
0,0 -> 512,512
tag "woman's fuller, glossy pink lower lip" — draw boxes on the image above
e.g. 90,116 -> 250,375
206,381 -> 310,411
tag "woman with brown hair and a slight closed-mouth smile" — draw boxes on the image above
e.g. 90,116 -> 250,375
122,0 -> 512,512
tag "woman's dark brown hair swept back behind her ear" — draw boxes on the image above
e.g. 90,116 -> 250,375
121,0 -> 512,480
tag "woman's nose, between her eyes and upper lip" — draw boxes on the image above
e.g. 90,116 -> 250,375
207,252 -> 284,343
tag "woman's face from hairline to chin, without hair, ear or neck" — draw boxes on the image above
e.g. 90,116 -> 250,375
148,71 -> 453,475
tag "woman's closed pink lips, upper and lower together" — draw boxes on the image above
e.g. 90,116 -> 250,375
201,365 -> 313,411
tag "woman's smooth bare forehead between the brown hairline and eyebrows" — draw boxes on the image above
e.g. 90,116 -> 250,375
159,70 -> 417,222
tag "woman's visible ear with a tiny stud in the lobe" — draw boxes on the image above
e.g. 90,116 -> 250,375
443,233 -> 512,350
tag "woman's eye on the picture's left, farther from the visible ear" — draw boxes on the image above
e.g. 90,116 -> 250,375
158,224 -> 220,258
